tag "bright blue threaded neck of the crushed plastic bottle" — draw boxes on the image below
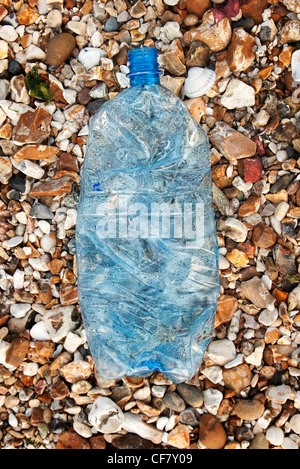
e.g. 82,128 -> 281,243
128,47 -> 162,86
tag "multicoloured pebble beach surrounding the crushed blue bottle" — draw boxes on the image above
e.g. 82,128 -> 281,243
0,0 -> 300,451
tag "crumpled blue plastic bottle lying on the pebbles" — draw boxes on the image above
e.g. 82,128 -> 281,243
76,48 -> 219,382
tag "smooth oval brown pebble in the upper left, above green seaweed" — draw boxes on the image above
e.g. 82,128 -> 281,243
46,33 -> 76,67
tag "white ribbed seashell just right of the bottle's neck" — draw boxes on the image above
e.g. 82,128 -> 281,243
184,67 -> 216,98
